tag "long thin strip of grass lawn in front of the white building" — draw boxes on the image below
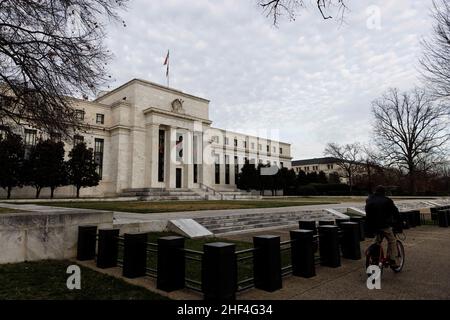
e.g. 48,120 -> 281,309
27,199 -> 336,213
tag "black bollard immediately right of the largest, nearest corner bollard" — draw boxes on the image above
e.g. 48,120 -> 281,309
253,235 -> 282,292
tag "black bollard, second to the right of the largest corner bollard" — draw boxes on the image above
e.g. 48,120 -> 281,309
290,229 -> 316,278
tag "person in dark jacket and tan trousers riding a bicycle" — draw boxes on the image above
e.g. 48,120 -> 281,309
366,186 -> 400,268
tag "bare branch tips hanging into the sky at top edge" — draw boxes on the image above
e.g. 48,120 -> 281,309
258,0 -> 348,25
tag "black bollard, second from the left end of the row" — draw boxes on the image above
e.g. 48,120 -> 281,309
97,229 -> 119,269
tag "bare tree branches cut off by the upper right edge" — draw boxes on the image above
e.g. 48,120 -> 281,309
420,0 -> 450,98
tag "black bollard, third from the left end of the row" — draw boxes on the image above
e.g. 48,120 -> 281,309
122,233 -> 147,278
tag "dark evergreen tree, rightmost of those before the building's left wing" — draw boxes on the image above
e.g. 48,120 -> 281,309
67,142 -> 100,198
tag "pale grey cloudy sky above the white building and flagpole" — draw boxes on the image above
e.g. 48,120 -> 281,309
106,0 -> 432,159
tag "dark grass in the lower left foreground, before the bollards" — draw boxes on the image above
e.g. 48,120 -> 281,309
0,260 -> 167,300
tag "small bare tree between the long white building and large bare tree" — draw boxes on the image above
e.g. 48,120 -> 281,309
324,143 -> 362,193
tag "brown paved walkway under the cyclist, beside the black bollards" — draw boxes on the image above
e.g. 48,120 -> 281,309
236,226 -> 450,300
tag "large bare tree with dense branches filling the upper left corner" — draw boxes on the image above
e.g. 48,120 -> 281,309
0,0 -> 128,135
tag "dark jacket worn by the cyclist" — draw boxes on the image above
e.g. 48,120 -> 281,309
366,194 -> 399,232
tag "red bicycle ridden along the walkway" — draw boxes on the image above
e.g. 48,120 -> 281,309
365,232 -> 405,277
